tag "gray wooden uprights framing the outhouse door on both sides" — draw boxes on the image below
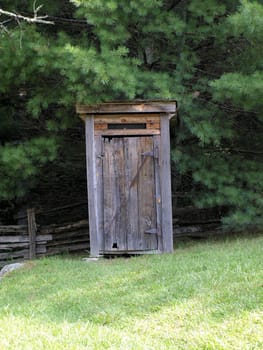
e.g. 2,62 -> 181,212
81,113 -> 173,256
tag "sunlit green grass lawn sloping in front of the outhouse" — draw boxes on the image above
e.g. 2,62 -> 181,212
0,236 -> 263,350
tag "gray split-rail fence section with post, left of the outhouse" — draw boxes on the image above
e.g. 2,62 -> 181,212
0,209 -> 89,267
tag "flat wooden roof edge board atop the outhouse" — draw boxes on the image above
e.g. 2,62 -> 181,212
76,101 -> 176,114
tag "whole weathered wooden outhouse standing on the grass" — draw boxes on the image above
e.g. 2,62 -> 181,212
77,101 -> 176,256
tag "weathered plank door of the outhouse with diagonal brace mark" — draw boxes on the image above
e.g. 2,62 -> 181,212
102,136 -> 158,252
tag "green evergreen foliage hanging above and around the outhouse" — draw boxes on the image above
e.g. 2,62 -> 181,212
0,0 -> 263,225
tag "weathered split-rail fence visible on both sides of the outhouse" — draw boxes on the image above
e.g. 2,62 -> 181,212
0,203 -> 222,268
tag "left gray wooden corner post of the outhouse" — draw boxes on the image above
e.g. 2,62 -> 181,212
85,116 -> 101,256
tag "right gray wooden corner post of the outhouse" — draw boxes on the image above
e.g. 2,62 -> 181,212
160,115 -> 173,253
